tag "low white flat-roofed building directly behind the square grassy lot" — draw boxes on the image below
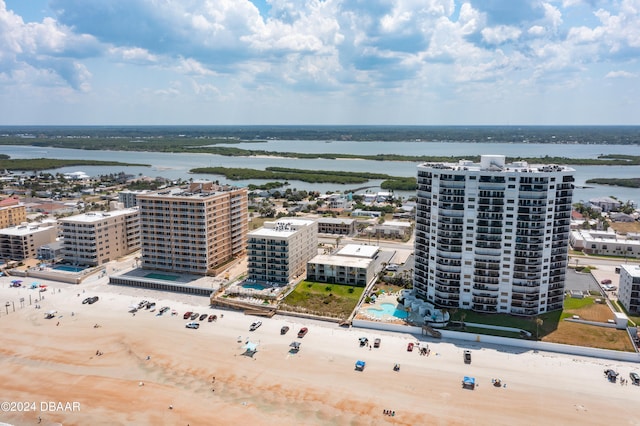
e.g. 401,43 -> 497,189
307,244 -> 379,287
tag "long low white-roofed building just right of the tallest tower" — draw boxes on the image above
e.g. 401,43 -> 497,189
569,229 -> 640,259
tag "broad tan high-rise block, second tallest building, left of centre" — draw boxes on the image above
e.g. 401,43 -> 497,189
136,182 -> 248,275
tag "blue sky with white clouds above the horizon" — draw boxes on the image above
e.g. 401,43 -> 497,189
0,0 -> 640,125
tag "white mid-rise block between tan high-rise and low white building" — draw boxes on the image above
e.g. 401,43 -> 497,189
247,218 -> 318,286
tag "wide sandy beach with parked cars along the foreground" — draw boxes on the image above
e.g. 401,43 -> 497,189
0,277 -> 640,425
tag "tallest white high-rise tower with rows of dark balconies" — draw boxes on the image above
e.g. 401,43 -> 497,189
414,155 -> 574,316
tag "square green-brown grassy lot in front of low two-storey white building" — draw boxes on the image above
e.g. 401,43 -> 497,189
280,281 -> 364,319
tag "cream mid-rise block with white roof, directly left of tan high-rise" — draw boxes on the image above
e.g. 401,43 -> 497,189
59,208 -> 140,266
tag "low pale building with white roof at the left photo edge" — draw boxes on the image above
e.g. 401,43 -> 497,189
0,222 -> 58,262
